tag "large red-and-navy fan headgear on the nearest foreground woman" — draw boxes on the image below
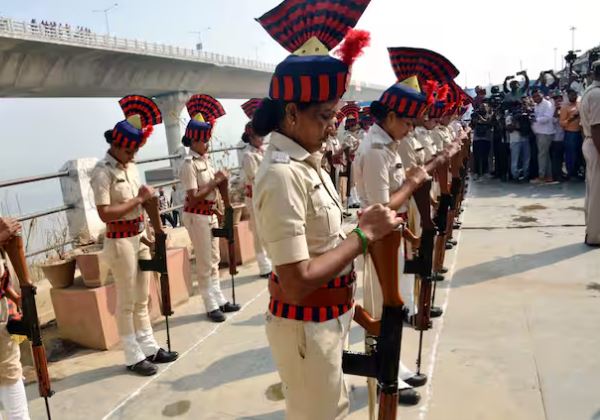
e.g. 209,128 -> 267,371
257,0 -> 370,102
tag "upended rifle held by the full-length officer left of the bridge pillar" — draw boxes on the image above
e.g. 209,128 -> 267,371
138,197 -> 174,351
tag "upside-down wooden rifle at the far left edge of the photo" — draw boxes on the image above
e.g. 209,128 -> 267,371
4,235 -> 54,420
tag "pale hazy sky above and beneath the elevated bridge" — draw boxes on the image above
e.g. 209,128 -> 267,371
0,0 -> 600,213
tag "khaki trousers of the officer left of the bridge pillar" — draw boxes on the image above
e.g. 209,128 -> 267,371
101,235 -> 159,365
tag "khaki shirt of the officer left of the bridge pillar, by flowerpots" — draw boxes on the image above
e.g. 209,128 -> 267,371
90,153 -> 144,220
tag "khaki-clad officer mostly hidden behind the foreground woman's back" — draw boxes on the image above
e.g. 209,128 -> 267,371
242,123 -> 272,278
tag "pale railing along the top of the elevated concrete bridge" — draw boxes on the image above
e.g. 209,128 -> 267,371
0,17 -> 275,72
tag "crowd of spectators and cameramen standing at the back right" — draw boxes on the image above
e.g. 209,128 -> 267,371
471,70 -> 585,184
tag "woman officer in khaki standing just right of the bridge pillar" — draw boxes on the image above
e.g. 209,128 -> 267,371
179,95 -> 240,322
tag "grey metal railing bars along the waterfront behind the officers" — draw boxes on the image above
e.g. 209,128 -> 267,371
0,146 -> 241,257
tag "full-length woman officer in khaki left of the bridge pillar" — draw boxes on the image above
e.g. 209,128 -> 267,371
90,95 -> 178,376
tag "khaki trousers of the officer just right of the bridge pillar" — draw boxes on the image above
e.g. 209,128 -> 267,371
183,212 -> 227,312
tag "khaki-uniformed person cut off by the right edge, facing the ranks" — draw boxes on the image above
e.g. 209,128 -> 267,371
580,61 -> 600,246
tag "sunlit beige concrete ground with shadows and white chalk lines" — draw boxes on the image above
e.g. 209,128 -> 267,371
18,181 -> 600,420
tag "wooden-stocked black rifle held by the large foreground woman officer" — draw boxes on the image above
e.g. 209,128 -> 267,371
342,230 -> 405,420
